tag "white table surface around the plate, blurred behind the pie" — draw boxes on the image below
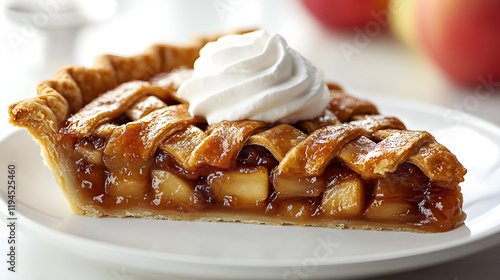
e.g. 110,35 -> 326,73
0,0 -> 500,280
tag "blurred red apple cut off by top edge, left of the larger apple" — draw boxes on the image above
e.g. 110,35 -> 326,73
302,0 -> 388,29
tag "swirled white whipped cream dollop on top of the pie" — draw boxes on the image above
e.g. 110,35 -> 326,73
177,30 -> 329,124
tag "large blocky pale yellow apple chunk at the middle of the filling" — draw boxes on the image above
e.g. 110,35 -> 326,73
209,166 -> 269,207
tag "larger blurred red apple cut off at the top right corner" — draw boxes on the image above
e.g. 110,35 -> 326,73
416,0 -> 500,86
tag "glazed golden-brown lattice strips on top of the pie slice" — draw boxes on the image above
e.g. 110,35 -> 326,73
54,74 -> 464,182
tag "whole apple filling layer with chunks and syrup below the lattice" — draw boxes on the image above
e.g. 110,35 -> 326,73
64,133 -> 463,231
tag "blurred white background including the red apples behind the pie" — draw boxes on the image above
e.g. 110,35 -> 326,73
0,0 -> 500,280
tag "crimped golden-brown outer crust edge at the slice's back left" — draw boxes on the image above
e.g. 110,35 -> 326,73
9,45 -> 200,137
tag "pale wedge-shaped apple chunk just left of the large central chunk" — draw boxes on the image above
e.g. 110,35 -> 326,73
151,170 -> 196,205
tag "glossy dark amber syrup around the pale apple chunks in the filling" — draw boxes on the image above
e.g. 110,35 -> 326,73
62,129 -> 464,232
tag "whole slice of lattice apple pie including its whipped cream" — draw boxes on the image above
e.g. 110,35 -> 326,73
9,30 -> 466,232
